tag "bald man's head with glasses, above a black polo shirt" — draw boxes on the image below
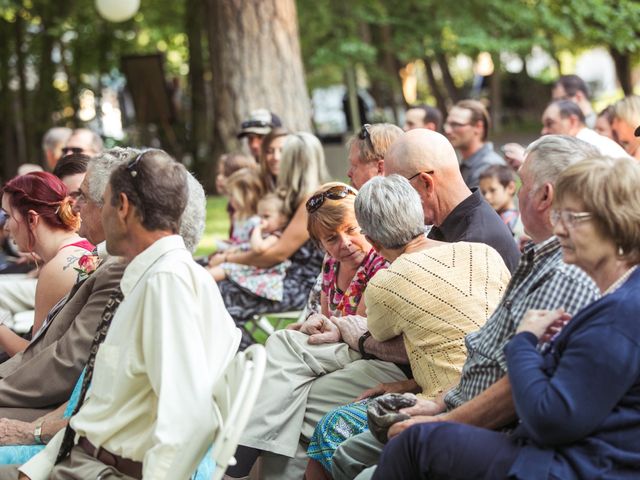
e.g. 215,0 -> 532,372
384,129 -> 471,225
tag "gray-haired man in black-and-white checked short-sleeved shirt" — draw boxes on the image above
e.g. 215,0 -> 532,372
333,135 -> 599,479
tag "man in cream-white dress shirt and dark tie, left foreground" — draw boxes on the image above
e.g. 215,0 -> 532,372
20,150 -> 239,480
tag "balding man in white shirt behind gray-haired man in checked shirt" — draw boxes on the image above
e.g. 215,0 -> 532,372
540,100 -> 627,158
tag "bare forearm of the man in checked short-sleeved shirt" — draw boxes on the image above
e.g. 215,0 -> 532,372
441,375 -> 517,430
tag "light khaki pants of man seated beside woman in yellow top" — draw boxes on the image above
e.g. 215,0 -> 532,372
240,330 -> 407,479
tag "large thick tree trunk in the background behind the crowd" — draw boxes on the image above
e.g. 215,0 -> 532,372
205,0 -> 311,190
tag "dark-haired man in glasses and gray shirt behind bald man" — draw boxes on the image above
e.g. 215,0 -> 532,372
444,100 -> 506,188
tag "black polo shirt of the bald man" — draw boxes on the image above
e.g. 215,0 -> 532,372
428,188 -> 520,273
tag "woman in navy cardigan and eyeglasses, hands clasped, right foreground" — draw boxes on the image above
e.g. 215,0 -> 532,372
373,157 -> 640,480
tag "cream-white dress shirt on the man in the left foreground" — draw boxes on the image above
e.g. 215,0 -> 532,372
20,235 -> 240,480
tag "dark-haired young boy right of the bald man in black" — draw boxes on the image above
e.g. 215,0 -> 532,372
480,165 -> 524,244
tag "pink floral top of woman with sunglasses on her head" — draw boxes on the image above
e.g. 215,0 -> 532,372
322,248 -> 389,317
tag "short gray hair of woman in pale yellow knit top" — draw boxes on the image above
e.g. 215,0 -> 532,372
355,175 -> 424,250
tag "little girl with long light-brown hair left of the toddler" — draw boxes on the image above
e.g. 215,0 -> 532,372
217,168 -> 263,251
